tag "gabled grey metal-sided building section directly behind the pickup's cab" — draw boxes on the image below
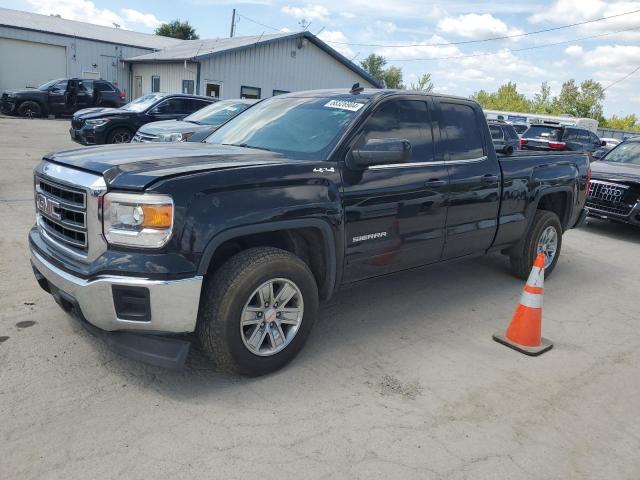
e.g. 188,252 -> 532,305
125,32 -> 381,99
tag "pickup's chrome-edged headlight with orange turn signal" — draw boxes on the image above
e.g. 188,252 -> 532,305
103,192 -> 173,248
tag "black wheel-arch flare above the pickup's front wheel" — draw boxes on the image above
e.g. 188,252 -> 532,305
198,218 -> 337,297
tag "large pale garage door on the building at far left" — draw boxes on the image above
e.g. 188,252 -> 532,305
0,38 -> 67,91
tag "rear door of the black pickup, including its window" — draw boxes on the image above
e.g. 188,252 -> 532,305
437,99 -> 501,259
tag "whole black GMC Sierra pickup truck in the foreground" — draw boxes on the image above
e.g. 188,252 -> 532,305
29,86 -> 590,375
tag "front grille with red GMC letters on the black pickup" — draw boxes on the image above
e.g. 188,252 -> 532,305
35,177 -> 89,254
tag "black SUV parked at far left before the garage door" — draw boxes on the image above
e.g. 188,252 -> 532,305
0,78 -> 125,117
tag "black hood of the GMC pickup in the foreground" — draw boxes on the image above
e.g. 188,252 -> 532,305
44,143 -> 297,190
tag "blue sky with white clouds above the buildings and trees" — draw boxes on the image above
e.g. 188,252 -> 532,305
0,0 -> 640,115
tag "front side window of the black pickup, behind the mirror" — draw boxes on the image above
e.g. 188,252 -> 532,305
358,100 -> 434,162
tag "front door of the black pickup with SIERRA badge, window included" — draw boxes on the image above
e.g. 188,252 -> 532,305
342,96 -> 449,282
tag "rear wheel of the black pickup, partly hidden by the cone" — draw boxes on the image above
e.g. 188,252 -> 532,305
510,210 -> 562,280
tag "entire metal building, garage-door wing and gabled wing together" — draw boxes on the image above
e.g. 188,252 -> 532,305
0,8 -> 381,98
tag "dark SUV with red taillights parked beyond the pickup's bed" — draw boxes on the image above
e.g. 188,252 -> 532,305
520,124 -> 606,153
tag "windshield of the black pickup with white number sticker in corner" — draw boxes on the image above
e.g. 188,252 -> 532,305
206,96 -> 368,160
